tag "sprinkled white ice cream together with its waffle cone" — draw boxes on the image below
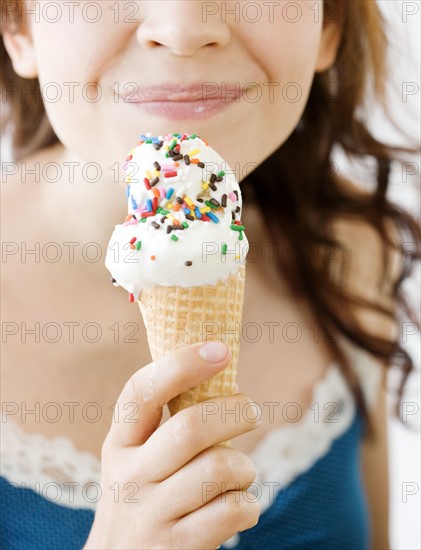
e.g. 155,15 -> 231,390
105,132 -> 249,448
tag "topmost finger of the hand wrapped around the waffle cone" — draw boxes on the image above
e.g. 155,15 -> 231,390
106,341 -> 231,447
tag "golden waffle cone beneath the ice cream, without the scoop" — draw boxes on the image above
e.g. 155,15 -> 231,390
139,266 -> 245,444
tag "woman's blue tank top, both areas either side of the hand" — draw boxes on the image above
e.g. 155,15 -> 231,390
0,414 -> 369,550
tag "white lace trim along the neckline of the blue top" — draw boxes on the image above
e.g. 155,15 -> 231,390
0,336 -> 381,528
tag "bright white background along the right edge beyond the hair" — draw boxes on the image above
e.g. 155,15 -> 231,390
378,0 -> 421,550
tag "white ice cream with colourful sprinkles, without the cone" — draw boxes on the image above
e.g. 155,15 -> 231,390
105,134 -> 248,301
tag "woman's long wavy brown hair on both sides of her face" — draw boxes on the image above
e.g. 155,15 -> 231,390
0,0 -> 421,427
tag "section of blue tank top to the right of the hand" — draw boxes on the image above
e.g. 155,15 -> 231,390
221,414 -> 370,550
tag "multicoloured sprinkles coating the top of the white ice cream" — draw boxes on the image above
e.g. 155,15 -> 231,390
118,133 -> 244,302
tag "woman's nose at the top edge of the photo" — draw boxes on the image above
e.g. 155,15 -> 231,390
137,0 -> 230,57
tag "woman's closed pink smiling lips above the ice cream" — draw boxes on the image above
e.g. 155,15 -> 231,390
120,82 -> 241,120
